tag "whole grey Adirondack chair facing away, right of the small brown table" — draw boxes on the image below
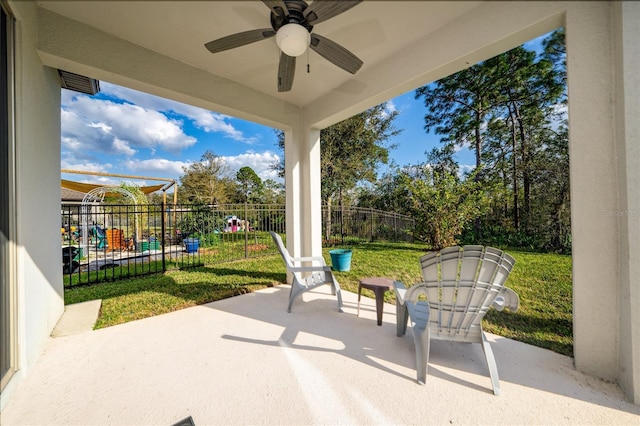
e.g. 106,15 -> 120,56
394,246 -> 520,395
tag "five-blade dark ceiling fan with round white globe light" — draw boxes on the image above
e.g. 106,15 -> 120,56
205,0 -> 362,92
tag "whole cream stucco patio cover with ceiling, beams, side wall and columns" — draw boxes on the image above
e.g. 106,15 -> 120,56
0,0 -> 640,410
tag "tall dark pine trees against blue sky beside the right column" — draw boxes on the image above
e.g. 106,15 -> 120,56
416,30 -> 570,248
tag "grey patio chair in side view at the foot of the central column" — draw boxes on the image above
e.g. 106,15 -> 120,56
270,231 -> 342,312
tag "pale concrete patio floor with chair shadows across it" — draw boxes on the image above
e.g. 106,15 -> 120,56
1,285 -> 640,426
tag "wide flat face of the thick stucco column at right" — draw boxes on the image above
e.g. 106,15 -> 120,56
566,2 -> 620,381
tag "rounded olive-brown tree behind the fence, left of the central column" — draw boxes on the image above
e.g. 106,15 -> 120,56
178,151 -> 234,204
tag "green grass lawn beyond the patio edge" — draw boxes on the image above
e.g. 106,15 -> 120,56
65,243 -> 573,356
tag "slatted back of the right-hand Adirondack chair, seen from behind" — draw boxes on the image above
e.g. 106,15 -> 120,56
420,245 -> 515,340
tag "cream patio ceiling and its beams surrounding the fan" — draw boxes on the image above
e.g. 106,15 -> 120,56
33,1 -> 562,128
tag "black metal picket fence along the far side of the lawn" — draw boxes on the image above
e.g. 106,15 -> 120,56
61,203 -> 414,287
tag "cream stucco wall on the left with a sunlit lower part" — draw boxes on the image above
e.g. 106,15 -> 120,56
1,2 -> 64,412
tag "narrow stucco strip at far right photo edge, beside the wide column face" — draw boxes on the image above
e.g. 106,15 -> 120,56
613,2 -> 640,405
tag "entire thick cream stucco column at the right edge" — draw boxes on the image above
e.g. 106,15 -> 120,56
566,2 -> 640,404
